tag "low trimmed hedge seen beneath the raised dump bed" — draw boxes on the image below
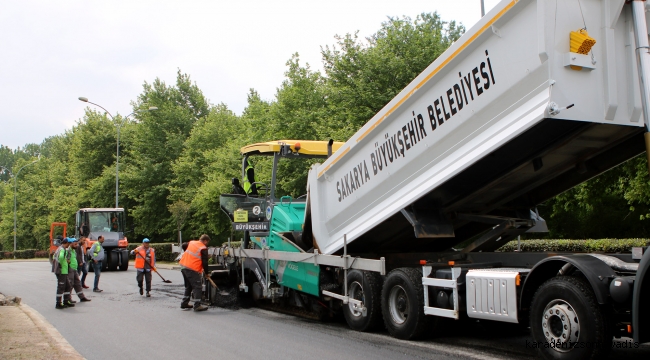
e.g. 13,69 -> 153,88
497,239 -> 650,253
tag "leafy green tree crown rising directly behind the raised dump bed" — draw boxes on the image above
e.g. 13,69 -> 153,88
320,13 -> 465,140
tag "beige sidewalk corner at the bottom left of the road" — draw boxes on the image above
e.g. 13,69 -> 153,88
0,296 -> 84,360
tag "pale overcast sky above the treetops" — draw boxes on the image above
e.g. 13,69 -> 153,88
0,0 -> 499,149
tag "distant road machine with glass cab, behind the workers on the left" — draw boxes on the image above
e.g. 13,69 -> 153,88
75,208 -> 129,271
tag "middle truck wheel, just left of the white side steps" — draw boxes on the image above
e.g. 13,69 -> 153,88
381,268 -> 431,340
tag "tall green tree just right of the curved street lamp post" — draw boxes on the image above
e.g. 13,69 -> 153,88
121,70 -> 209,239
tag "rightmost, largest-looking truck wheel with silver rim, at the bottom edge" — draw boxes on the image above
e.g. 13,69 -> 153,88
530,276 -> 612,360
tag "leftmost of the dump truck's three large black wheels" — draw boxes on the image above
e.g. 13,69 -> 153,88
343,270 -> 383,331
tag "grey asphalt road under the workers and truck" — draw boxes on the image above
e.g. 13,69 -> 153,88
0,261 -> 650,360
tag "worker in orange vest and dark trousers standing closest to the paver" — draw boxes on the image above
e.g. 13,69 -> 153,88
180,234 -> 210,311
